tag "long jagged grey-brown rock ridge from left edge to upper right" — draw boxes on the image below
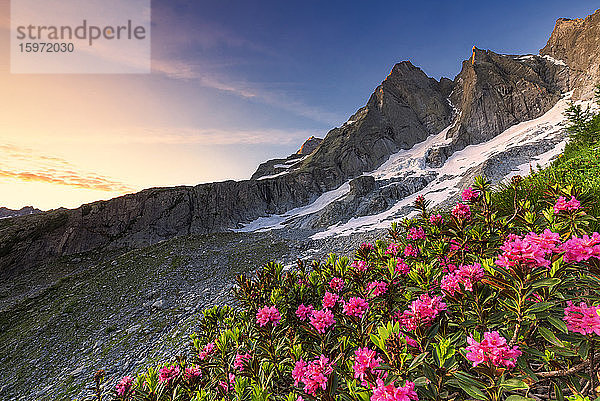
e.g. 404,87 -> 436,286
0,8 -> 600,272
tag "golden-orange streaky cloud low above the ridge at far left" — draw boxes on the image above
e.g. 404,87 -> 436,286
0,145 -> 133,193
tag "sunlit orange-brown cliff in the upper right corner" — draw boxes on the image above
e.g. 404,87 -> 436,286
540,10 -> 600,99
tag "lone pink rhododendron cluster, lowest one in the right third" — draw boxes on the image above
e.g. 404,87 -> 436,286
466,331 -> 521,368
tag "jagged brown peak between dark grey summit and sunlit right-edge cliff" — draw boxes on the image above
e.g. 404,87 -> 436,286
428,47 -> 569,167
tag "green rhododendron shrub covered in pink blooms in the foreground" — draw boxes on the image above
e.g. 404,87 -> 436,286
105,178 -> 600,401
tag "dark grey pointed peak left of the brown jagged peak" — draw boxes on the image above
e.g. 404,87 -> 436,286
303,61 -> 452,186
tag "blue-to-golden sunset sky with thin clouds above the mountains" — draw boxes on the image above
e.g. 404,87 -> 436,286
0,0 -> 597,209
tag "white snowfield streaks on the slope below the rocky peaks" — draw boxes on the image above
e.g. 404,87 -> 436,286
233,93 -> 590,239
